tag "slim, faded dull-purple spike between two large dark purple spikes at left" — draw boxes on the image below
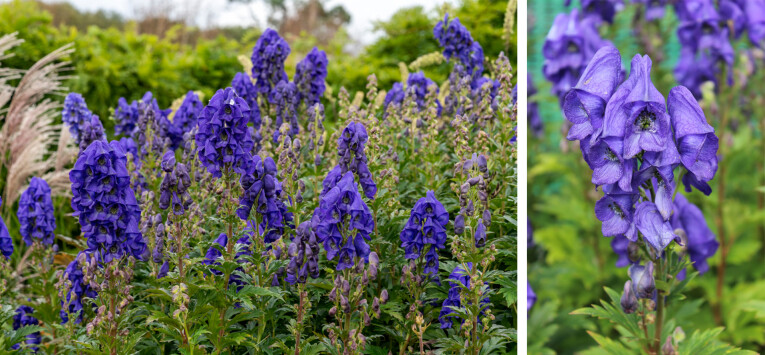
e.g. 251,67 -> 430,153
159,151 -> 191,215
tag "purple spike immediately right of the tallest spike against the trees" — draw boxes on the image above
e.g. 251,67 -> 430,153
295,47 -> 328,107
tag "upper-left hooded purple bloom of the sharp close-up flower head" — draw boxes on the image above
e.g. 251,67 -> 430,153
562,46 -> 623,140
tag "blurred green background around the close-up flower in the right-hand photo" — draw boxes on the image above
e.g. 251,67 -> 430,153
527,0 -> 765,354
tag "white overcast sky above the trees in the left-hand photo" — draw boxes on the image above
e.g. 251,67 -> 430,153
44,0 -> 455,44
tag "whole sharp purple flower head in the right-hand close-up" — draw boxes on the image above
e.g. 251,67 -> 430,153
563,47 -> 718,256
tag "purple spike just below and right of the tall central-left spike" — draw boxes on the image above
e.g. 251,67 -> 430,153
236,155 -> 293,243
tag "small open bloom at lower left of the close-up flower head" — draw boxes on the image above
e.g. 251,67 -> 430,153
595,185 -> 640,241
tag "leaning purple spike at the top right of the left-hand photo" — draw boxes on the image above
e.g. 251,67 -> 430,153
433,14 -> 483,81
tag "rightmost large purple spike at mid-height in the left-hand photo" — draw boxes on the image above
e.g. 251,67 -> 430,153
399,190 -> 449,276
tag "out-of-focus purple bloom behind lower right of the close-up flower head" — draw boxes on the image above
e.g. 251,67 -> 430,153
671,194 -> 719,278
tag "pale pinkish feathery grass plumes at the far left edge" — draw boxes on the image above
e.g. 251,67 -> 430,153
0,33 -> 74,206
